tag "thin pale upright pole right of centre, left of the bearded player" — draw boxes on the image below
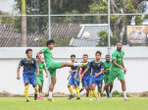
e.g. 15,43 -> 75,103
108,0 -> 111,55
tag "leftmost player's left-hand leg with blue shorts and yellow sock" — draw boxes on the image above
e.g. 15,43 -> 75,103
23,74 -> 29,102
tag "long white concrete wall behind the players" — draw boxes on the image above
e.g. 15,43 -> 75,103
0,47 -> 148,94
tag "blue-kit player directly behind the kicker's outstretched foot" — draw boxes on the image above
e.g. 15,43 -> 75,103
67,55 -> 80,100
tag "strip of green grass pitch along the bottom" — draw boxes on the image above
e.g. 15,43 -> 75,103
0,97 -> 148,110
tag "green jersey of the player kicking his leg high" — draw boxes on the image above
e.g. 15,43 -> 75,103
41,47 -> 54,67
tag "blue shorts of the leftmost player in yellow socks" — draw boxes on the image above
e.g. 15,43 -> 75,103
23,74 -> 37,87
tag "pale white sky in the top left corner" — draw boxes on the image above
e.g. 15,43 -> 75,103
0,0 -> 15,13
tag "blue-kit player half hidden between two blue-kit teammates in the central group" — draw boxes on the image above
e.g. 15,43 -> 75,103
81,54 -> 91,97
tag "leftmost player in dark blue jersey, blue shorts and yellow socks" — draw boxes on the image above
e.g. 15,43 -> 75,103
17,49 -> 39,102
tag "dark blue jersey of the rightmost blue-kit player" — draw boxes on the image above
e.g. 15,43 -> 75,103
89,60 -> 104,77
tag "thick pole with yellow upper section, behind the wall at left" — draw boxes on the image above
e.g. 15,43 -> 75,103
21,0 -> 27,47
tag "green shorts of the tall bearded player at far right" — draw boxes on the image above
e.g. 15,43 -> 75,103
109,69 -> 125,83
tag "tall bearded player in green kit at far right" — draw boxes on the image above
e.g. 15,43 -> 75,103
110,42 -> 127,100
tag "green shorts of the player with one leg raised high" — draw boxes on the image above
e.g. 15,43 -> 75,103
47,62 -> 62,78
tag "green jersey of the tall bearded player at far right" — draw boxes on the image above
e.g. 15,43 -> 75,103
112,50 -> 124,70
